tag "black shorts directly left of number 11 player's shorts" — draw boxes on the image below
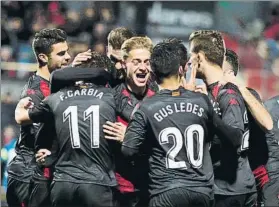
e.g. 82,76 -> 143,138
28,177 -> 51,207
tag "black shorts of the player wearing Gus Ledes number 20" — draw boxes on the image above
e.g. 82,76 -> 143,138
149,188 -> 211,207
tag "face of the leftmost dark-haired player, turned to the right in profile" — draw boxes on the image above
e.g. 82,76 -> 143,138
48,42 -> 71,72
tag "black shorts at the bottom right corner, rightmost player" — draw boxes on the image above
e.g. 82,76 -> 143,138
262,178 -> 279,206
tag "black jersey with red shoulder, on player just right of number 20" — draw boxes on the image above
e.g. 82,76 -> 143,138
208,82 -> 256,195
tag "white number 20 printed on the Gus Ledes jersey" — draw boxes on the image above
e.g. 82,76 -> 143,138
159,124 -> 204,169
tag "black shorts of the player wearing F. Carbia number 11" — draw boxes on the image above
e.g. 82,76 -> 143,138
50,181 -> 116,207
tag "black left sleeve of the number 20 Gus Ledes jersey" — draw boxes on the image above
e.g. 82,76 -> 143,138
121,109 -> 147,157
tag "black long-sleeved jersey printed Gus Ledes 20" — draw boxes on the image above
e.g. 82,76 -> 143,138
122,88 -> 215,196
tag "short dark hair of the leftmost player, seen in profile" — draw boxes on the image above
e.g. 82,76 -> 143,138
32,28 -> 67,65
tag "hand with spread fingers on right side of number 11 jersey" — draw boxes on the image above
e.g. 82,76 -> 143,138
103,121 -> 127,142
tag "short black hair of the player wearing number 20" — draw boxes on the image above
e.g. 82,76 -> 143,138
150,42 -> 180,84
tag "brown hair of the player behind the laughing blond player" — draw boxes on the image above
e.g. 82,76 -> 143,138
108,27 -> 135,50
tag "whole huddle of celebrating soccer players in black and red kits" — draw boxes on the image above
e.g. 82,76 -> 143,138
6,27 -> 279,207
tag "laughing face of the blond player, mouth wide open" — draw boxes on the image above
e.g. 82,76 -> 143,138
125,49 -> 151,87
